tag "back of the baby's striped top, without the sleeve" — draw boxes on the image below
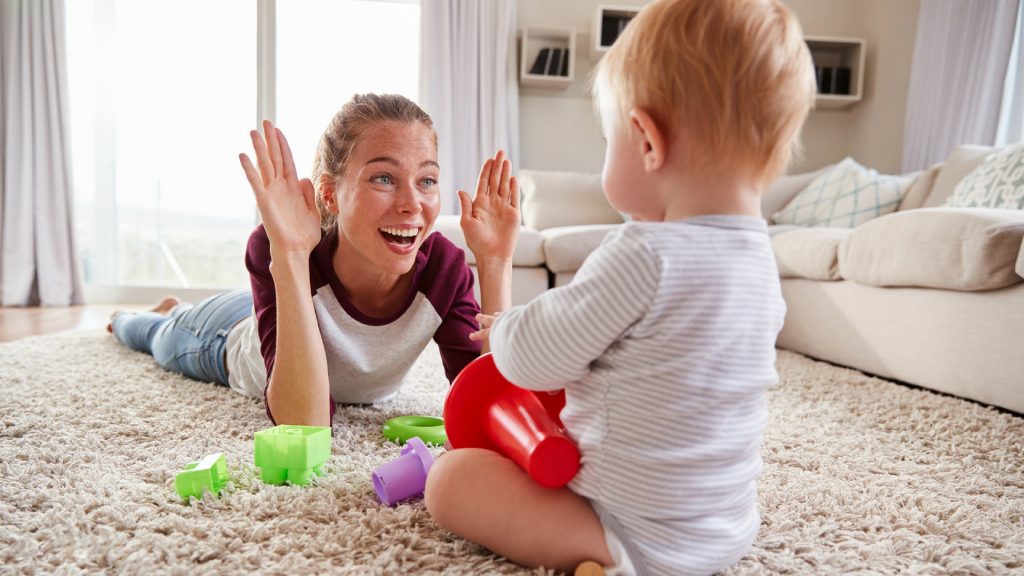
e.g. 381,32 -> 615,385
562,216 -> 785,573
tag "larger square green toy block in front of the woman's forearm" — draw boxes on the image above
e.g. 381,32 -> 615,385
254,424 -> 331,486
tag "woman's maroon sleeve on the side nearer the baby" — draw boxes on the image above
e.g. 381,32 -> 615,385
421,233 -> 480,382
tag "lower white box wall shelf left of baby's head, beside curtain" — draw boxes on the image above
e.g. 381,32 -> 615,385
519,28 -> 575,88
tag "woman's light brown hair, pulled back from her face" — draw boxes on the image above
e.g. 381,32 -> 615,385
309,94 -> 437,234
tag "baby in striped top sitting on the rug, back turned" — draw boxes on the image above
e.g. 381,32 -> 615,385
426,0 -> 814,575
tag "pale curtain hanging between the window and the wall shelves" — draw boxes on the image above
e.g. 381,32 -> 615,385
420,0 -> 519,214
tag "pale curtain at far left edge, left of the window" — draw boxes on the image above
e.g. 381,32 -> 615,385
0,0 -> 82,305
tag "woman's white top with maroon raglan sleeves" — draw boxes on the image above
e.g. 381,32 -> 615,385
227,225 -> 480,421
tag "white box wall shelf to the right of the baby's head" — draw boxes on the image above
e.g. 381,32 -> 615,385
804,36 -> 867,110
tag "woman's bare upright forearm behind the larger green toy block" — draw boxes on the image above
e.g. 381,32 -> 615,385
266,253 -> 331,426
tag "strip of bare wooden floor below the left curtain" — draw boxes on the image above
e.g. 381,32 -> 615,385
0,304 -> 146,342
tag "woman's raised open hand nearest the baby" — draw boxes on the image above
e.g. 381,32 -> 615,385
459,151 -> 520,262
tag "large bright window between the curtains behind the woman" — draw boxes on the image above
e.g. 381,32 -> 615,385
67,0 -> 419,297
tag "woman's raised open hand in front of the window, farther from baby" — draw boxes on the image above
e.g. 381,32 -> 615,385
239,120 -> 321,254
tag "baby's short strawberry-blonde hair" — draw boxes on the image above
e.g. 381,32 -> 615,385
594,0 -> 815,183
